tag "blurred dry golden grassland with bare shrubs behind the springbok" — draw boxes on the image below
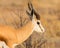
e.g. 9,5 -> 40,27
0,0 -> 60,48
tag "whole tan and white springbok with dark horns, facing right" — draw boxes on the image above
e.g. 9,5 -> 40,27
0,3 -> 44,48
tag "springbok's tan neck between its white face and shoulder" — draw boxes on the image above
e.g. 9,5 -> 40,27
17,21 -> 34,43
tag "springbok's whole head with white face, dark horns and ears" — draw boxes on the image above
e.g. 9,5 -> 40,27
26,3 -> 45,33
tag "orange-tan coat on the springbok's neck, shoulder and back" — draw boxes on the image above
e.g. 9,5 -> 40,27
0,21 -> 34,48
